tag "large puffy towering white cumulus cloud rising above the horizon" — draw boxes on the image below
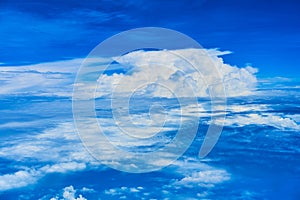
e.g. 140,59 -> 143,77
98,49 -> 257,97
